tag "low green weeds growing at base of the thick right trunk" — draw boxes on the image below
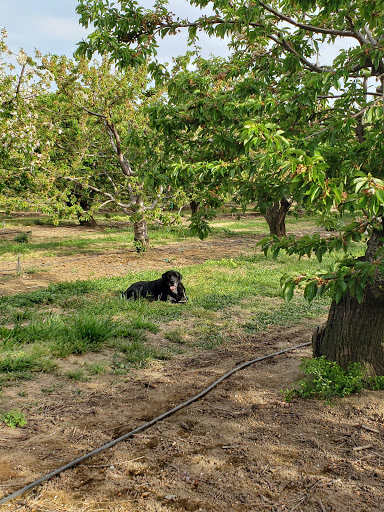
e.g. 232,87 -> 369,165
284,357 -> 384,401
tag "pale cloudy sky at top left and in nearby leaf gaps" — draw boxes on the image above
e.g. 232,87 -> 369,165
0,0 -> 228,62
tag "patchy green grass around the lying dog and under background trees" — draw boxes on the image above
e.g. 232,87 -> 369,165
0,212 -> 366,384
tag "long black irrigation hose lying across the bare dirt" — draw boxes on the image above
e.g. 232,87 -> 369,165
0,341 -> 311,505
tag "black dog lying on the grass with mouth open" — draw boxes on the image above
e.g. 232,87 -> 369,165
122,270 -> 188,302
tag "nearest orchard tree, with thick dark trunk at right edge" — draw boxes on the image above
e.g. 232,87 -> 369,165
77,0 -> 384,375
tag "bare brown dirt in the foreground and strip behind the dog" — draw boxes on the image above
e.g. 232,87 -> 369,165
0,224 -> 384,512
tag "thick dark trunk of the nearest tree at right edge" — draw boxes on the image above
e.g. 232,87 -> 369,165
312,231 -> 384,376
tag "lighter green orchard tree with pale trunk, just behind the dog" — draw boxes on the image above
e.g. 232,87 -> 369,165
43,57 -> 175,248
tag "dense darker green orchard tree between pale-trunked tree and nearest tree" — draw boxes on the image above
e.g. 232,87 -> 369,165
150,54 -> 292,237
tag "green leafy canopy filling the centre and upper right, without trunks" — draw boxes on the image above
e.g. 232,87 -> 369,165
73,0 -> 384,316
